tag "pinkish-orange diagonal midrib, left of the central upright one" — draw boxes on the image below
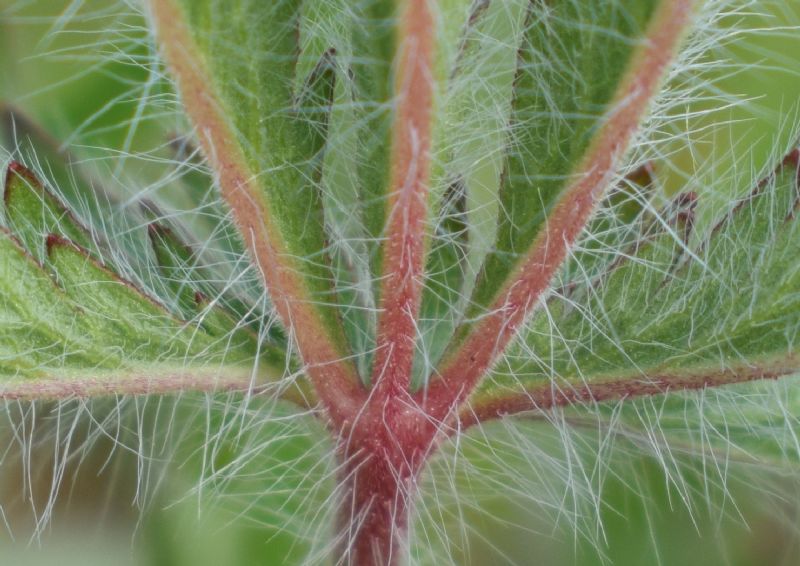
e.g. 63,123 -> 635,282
150,0 -> 366,426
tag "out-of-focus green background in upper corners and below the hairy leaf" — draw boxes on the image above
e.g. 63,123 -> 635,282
0,0 -> 800,566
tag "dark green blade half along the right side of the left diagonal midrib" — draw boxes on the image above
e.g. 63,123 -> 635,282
175,0 -> 350,358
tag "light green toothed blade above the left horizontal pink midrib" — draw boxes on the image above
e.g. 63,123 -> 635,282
0,226 -> 244,379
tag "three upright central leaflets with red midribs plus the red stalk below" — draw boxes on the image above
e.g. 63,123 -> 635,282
141,0 -> 694,563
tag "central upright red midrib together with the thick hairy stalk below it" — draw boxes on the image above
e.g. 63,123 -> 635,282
338,0 -> 436,566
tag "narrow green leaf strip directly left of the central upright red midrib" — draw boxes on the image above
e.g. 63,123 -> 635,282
296,0 -> 393,380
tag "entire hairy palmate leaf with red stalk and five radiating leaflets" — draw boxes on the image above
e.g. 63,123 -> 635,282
0,0 -> 800,565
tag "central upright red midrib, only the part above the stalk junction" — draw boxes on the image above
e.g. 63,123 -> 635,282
372,0 -> 435,399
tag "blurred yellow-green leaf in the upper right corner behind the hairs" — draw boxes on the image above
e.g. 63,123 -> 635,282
654,0 -> 800,245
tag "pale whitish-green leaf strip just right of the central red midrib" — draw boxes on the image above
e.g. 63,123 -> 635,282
412,0 -> 528,388
